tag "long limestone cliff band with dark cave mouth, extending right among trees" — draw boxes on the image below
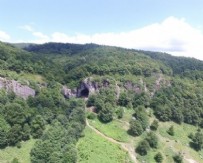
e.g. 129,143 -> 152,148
62,74 -> 170,99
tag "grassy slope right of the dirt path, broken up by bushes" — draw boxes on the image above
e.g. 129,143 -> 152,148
89,110 -> 203,163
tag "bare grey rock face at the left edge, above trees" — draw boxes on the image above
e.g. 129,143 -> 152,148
0,77 -> 35,99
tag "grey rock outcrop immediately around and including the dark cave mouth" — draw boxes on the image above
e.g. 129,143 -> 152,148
62,78 -> 110,98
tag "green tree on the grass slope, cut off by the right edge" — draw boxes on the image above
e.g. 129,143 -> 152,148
192,131 -> 203,151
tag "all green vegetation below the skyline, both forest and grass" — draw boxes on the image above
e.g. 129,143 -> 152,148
0,42 -> 203,163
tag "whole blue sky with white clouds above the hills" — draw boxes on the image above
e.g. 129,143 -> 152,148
0,0 -> 203,60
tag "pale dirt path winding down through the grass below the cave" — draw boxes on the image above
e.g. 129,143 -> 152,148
86,119 -> 137,163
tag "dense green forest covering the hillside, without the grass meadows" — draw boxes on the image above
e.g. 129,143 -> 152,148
0,42 -> 203,163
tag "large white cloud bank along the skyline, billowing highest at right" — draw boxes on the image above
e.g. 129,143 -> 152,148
18,17 -> 203,60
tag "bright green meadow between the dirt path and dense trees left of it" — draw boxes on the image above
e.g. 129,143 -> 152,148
77,127 -> 130,163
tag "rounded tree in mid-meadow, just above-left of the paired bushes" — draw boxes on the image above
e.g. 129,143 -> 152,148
128,119 -> 144,136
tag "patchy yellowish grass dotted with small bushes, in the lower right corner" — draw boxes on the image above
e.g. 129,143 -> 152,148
137,119 -> 203,163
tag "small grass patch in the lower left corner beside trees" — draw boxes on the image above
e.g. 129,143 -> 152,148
0,139 -> 36,163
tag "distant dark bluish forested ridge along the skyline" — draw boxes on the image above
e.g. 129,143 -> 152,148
24,43 -> 203,75
